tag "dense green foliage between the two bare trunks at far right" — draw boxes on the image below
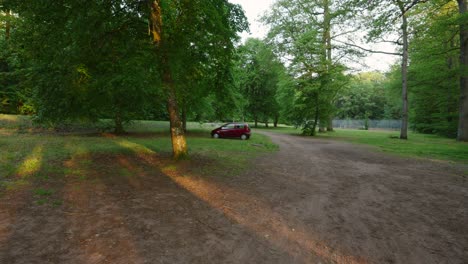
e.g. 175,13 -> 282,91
408,1 -> 459,137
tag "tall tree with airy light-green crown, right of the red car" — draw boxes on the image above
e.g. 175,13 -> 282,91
263,0 -> 352,134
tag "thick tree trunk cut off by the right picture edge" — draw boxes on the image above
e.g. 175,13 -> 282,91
457,0 -> 468,141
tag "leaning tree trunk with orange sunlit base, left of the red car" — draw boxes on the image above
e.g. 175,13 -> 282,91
148,0 -> 188,159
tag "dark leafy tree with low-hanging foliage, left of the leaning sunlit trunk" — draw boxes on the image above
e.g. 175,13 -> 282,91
8,0 -> 160,132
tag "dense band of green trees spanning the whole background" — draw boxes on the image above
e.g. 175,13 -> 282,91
0,0 -> 468,140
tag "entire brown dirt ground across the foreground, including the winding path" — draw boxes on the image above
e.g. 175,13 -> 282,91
0,134 -> 468,264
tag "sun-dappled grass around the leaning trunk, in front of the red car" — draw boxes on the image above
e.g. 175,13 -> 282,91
0,115 -> 277,196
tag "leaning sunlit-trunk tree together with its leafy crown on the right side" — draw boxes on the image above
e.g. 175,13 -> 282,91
147,0 -> 247,159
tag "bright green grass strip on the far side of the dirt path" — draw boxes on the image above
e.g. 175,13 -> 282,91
261,126 -> 468,164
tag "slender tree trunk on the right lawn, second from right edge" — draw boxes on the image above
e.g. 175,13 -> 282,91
399,2 -> 408,139
